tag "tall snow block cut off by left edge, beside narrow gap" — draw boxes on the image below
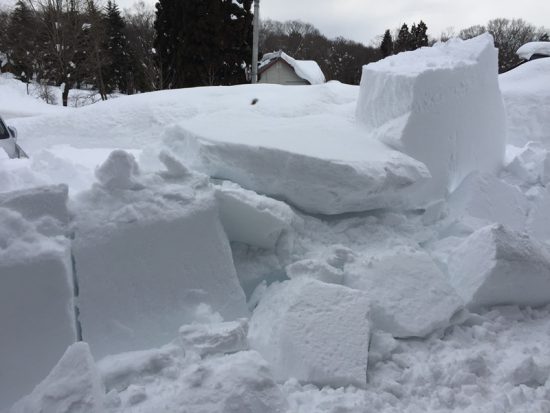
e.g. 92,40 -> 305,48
0,208 -> 76,410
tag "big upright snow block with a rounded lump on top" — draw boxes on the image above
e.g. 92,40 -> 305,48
72,151 -> 248,357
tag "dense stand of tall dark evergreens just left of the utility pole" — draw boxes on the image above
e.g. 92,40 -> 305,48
155,0 -> 252,88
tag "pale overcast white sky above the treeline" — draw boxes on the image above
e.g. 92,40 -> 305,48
0,0 -> 550,44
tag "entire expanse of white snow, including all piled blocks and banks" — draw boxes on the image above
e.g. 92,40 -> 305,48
0,35 -> 550,413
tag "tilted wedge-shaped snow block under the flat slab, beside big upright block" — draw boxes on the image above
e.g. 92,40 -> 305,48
216,182 -> 298,249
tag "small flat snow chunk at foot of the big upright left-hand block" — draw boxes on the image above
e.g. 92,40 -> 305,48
179,318 -> 248,356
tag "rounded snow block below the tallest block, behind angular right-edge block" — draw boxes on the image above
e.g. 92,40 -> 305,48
448,173 -> 529,231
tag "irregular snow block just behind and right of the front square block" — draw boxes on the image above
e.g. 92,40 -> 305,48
344,247 -> 464,337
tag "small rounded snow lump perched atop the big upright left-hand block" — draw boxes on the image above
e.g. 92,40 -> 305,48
95,149 -> 140,189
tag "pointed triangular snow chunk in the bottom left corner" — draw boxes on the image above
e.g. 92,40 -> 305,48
10,342 -> 105,413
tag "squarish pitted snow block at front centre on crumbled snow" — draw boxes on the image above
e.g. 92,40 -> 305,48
248,277 -> 370,387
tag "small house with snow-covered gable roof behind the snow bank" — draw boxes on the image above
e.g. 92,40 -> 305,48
258,50 -> 326,85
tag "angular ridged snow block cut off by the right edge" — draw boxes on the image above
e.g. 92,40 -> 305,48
449,225 -> 550,309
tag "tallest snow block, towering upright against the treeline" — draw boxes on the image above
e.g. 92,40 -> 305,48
356,34 -> 505,198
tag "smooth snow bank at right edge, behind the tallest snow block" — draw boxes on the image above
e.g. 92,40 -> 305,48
499,59 -> 550,149
